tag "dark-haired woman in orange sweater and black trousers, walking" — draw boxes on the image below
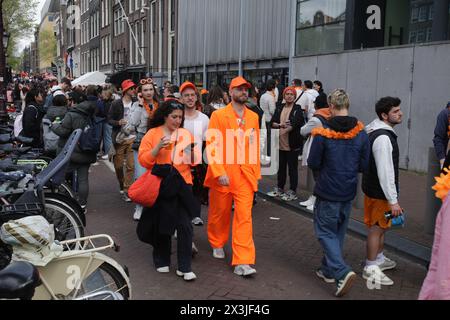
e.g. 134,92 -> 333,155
138,99 -> 198,281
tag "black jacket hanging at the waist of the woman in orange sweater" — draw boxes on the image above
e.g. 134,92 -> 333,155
137,164 -> 200,245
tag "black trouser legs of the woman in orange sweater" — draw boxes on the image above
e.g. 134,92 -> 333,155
153,215 -> 193,273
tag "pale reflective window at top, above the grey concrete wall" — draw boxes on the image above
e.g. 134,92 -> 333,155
295,0 -> 347,55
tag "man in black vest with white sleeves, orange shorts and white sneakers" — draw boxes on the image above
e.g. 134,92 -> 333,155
362,97 -> 403,286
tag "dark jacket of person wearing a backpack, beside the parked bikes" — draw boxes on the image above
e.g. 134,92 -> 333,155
51,101 -> 97,164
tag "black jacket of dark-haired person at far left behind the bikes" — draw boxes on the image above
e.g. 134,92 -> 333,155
21,104 -> 45,148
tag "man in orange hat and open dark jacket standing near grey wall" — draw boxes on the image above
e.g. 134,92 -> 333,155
268,87 -> 305,201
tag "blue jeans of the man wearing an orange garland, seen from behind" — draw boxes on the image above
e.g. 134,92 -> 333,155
314,198 -> 352,280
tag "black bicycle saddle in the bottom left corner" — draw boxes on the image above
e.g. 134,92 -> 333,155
0,261 -> 41,300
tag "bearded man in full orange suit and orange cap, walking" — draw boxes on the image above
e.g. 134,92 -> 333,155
205,77 -> 261,276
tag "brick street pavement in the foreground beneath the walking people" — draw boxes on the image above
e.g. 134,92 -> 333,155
87,162 -> 426,300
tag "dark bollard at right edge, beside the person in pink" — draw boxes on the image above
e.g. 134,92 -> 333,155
425,148 -> 442,235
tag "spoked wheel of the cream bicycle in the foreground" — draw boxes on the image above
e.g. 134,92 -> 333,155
68,262 -> 130,300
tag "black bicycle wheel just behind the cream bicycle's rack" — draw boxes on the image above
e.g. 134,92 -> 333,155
42,198 -> 84,241
